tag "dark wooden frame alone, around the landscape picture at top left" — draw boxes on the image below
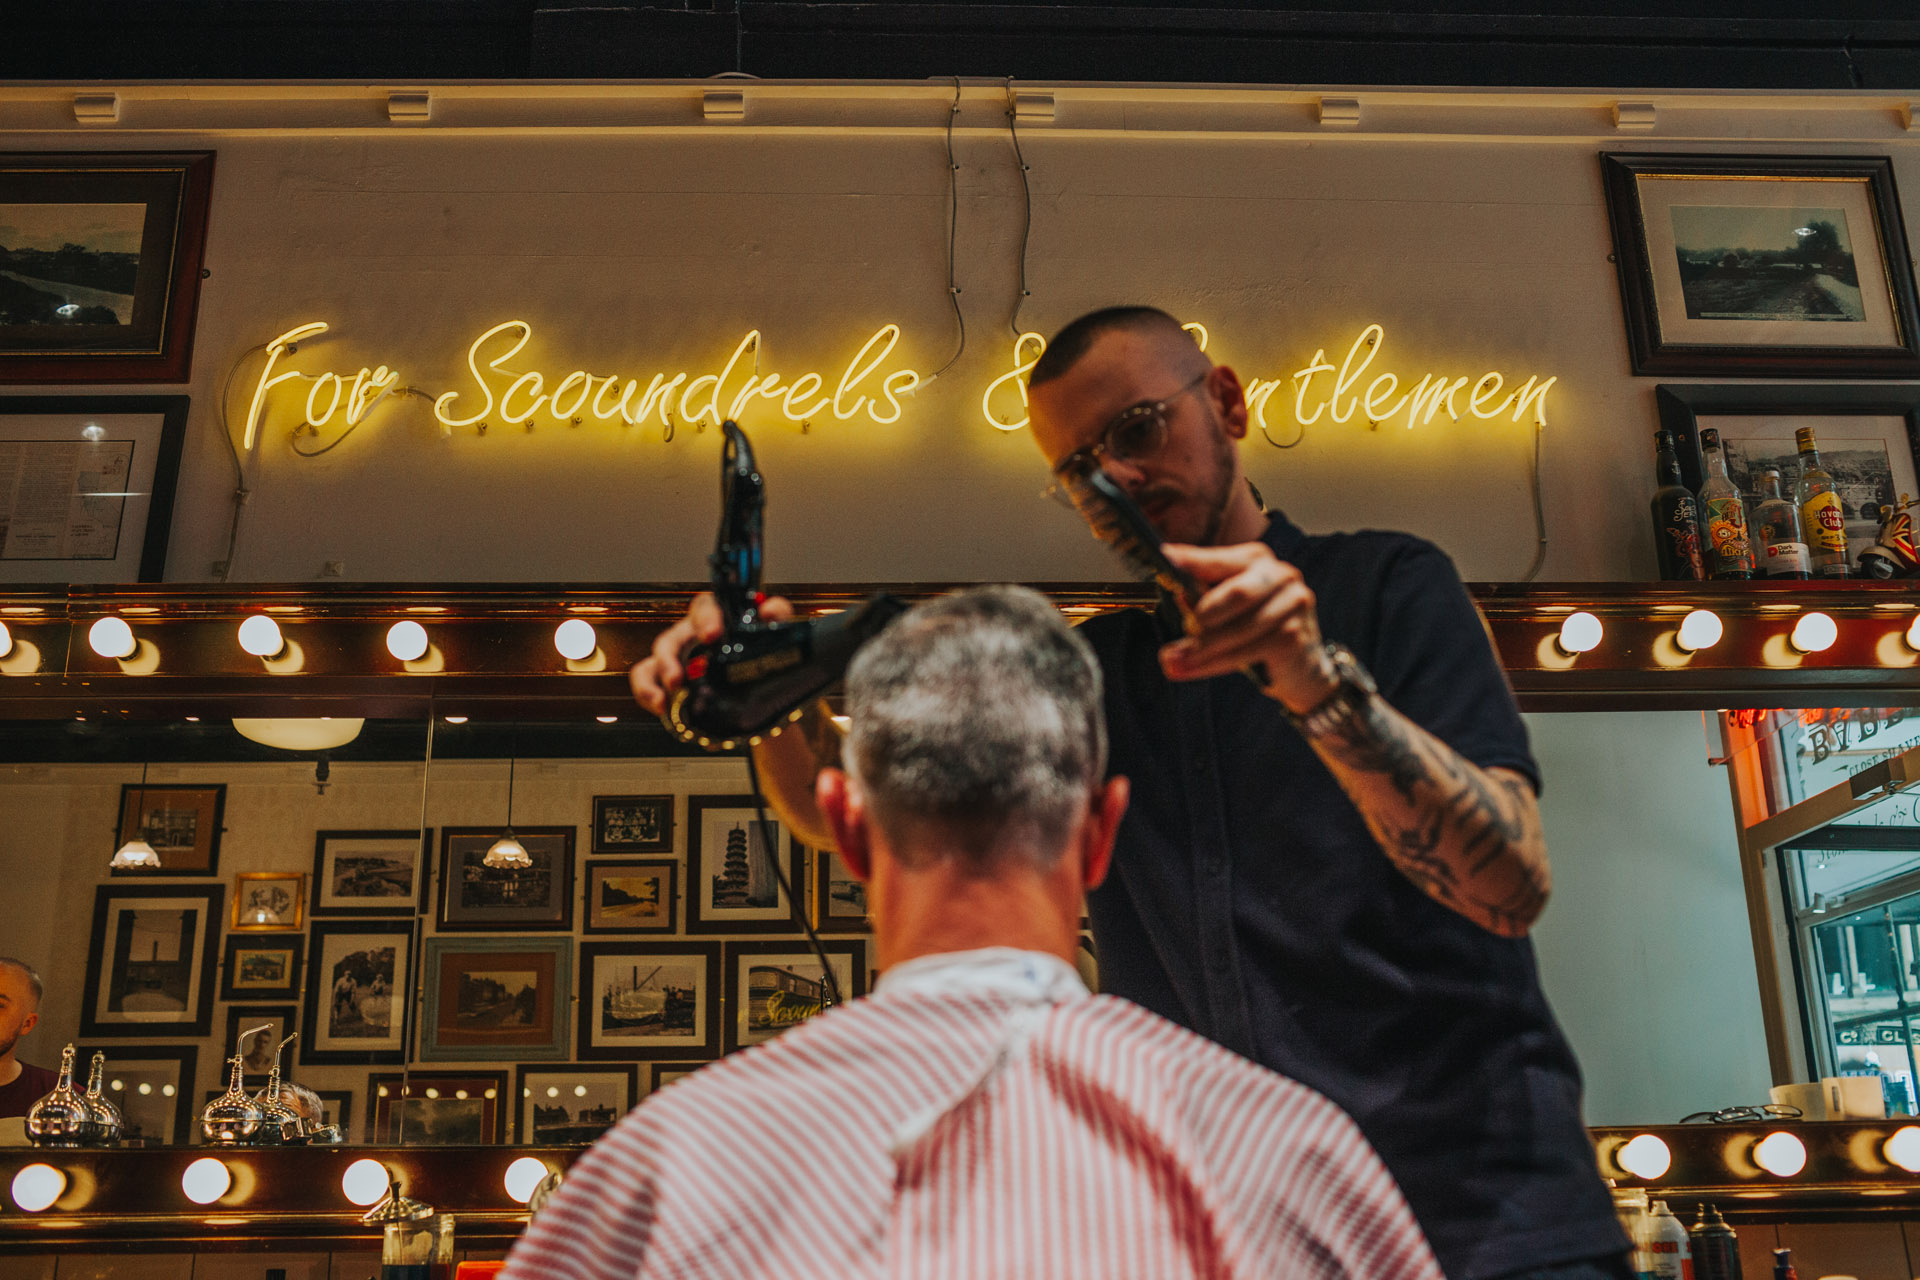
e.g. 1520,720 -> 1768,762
0,152 -> 213,382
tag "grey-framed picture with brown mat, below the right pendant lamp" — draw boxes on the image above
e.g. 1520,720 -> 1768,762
420,936 -> 574,1061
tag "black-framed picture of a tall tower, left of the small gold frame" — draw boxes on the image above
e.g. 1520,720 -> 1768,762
81,885 -> 225,1036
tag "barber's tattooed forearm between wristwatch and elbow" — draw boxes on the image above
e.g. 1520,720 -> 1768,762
1315,699 -> 1549,936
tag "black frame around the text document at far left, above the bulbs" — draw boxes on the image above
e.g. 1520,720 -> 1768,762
0,395 -> 192,583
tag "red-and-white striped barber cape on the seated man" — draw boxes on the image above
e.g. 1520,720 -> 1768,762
505,948 -> 1440,1280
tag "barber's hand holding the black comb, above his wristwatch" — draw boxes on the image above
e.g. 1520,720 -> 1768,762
1160,543 -> 1338,716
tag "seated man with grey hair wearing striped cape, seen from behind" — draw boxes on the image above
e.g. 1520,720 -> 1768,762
505,587 -> 1440,1280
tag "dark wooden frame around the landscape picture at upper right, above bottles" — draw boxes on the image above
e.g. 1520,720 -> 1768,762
1599,152 -> 1920,378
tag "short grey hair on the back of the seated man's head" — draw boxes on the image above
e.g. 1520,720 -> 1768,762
843,587 -> 1106,869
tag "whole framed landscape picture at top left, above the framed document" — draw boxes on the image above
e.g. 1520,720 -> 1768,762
0,152 -> 213,382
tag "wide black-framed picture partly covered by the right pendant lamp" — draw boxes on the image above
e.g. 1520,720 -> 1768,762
436,827 -> 574,933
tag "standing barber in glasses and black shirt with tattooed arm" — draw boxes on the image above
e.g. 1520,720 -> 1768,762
632,307 -> 1632,1280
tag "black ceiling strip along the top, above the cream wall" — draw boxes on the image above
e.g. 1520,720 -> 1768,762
11,0 -> 1920,90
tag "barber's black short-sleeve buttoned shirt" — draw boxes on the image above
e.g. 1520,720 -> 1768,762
1081,516 -> 1626,1280
